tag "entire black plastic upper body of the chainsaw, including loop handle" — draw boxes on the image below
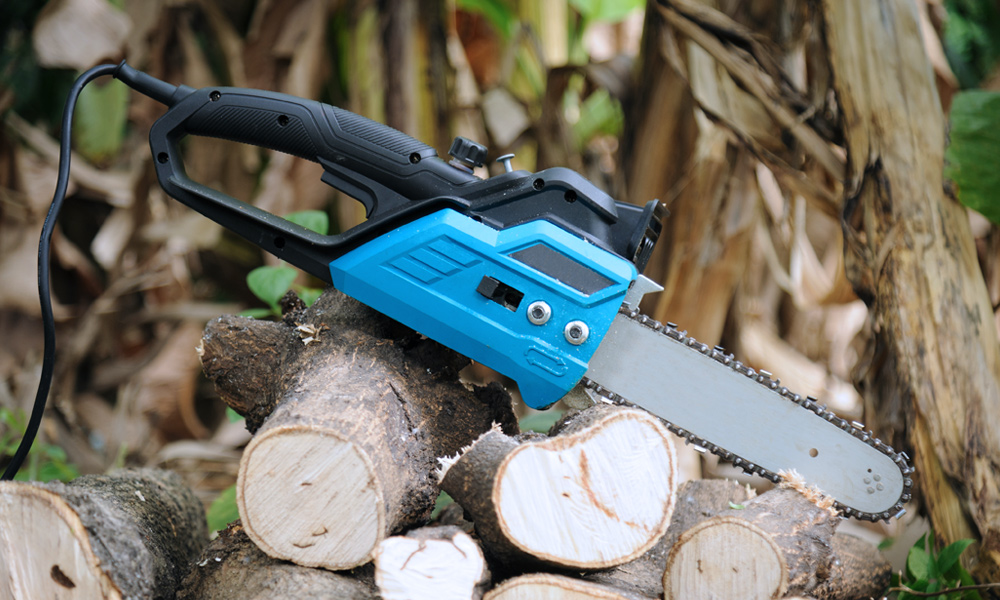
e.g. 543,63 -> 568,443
139,82 -> 663,282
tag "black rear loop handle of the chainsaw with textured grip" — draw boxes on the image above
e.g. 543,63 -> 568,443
149,87 -> 480,282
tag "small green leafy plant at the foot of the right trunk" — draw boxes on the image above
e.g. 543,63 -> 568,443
889,531 -> 981,600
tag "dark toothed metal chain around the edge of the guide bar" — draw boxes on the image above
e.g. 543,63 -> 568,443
596,306 -> 915,523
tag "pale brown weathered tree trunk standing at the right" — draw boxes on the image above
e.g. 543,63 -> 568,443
822,0 -> 1000,581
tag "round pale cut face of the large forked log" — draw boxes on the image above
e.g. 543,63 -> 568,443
236,426 -> 386,570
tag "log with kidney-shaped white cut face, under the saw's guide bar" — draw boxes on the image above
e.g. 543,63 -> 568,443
441,404 -> 677,570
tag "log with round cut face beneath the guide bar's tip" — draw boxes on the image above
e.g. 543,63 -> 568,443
663,487 -> 840,599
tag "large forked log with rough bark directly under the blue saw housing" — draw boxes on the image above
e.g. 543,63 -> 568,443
201,289 -> 517,570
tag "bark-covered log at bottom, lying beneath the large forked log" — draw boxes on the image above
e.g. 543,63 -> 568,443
177,521 -> 378,600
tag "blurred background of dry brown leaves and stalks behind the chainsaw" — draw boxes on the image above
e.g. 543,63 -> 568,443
0,0 -> 1000,580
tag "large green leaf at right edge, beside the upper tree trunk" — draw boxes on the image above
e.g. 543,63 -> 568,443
944,90 -> 1000,224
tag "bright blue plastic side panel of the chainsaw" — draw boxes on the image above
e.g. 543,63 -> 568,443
330,209 -> 636,408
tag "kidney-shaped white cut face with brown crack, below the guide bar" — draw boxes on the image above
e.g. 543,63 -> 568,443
493,409 -> 677,568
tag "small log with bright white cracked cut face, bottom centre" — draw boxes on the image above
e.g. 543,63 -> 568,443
375,525 -> 490,600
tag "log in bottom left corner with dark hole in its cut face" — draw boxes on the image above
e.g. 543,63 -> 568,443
0,469 -> 207,600
